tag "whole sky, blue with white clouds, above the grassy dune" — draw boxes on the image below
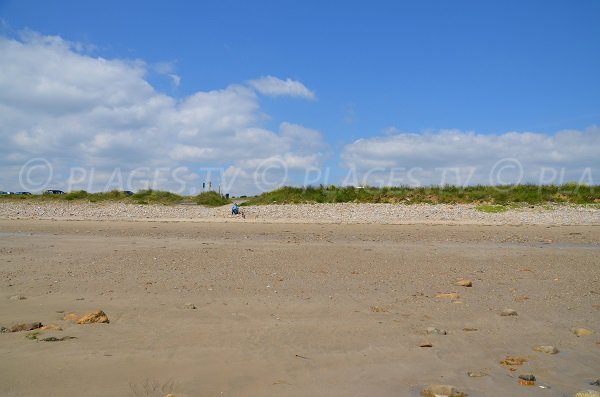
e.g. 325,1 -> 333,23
0,0 -> 600,195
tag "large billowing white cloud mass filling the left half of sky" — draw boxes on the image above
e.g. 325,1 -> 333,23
0,32 -> 324,194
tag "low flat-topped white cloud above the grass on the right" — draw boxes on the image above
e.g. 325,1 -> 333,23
342,126 -> 600,186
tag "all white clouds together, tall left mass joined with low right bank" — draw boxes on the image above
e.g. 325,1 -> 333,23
0,32 -> 600,194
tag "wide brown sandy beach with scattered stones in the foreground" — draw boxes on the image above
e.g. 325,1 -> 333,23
0,215 -> 600,397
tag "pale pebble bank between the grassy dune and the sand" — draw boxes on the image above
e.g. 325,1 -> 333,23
0,202 -> 600,225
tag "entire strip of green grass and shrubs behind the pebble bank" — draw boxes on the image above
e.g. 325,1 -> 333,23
0,183 -> 600,206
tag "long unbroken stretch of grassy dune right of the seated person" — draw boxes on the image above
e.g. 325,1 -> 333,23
244,184 -> 600,205
